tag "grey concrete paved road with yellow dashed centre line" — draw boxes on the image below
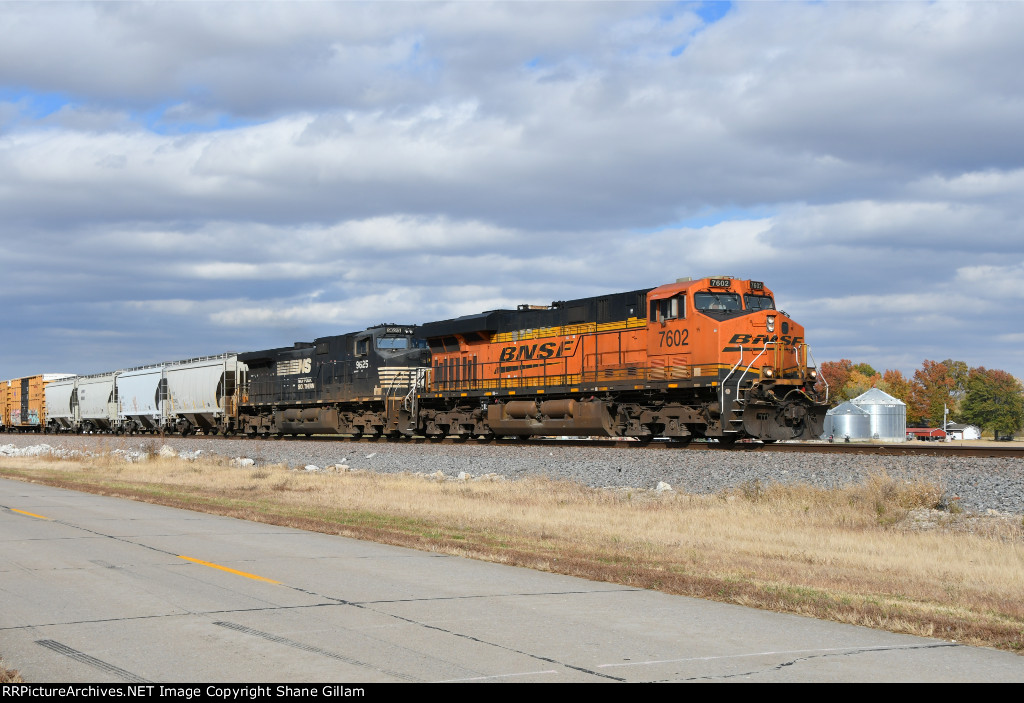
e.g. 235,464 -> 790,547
0,479 -> 1024,683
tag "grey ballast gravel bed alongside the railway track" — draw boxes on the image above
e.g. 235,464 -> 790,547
0,435 -> 1024,515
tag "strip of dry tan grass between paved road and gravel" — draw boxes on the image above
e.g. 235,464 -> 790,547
0,456 -> 1024,652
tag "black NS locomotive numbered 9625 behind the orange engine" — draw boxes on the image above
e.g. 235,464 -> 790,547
239,324 -> 430,437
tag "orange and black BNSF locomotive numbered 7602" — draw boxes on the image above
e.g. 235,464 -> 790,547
416,276 -> 826,442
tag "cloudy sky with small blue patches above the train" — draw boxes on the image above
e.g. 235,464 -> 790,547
0,2 -> 1024,379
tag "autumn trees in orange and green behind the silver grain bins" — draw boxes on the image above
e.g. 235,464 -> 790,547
816,359 -> 1024,435
